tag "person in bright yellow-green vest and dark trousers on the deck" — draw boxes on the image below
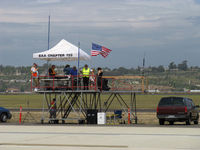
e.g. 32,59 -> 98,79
82,64 -> 90,90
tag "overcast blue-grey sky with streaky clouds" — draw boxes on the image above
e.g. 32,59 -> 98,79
0,0 -> 200,68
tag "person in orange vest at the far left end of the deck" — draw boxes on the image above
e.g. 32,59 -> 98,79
31,63 -> 39,91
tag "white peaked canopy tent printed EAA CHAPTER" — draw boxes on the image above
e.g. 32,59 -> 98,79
33,39 -> 90,61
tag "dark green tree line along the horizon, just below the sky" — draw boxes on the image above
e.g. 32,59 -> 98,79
0,60 -> 200,79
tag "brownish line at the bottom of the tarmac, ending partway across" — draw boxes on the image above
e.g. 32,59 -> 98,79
0,143 -> 128,148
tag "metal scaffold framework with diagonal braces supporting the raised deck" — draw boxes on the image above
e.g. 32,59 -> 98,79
37,90 -> 137,124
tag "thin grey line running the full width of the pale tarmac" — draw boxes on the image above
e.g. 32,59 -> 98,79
0,131 -> 200,137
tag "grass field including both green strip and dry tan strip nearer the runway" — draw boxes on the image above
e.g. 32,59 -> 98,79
0,94 -> 200,124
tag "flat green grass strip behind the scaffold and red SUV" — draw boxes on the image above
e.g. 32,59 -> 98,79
0,94 -> 200,109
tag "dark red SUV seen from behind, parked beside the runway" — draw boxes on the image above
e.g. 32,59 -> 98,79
157,97 -> 199,125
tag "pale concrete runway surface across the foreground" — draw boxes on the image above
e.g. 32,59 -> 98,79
0,125 -> 200,150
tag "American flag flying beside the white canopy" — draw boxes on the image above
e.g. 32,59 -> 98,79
91,43 -> 112,58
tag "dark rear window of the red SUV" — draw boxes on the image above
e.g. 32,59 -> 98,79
159,97 -> 184,106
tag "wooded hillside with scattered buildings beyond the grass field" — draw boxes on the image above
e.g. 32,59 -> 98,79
0,60 -> 200,92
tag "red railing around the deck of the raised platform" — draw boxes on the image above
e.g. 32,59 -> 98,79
31,75 -> 148,92
